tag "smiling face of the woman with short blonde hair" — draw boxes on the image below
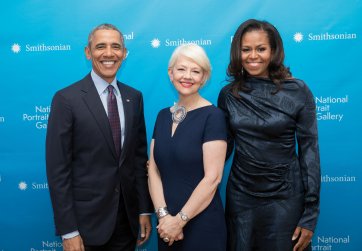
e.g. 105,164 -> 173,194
168,56 -> 205,96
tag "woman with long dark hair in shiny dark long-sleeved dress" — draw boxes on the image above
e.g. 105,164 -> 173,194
218,19 -> 320,251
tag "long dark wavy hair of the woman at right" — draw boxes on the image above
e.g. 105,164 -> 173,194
227,19 -> 292,97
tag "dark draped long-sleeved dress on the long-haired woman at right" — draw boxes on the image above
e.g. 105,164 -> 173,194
218,78 -> 320,251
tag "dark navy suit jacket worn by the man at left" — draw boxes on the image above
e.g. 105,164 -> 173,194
46,74 -> 152,245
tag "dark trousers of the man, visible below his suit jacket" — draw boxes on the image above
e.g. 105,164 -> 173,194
85,197 -> 137,251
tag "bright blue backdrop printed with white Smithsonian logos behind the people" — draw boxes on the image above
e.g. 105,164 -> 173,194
0,0 -> 362,251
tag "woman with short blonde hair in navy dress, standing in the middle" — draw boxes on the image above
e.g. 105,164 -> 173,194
148,44 -> 227,251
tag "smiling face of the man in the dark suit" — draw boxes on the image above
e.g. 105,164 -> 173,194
85,30 -> 126,83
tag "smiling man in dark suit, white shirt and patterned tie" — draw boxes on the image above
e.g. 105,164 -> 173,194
46,24 -> 153,251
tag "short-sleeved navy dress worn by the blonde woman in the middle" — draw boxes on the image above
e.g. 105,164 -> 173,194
153,105 -> 227,251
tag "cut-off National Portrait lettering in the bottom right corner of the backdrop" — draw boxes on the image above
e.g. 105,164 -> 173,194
312,235 -> 351,251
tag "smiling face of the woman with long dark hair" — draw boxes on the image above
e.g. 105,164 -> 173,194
241,30 -> 272,77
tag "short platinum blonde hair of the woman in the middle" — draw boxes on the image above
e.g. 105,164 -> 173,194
168,43 -> 211,84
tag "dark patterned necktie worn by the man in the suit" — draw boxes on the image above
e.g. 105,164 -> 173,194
107,85 -> 121,157
